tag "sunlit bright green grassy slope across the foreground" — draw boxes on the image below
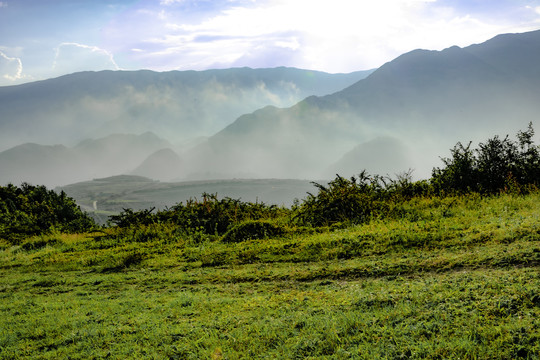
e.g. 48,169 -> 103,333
0,194 -> 540,359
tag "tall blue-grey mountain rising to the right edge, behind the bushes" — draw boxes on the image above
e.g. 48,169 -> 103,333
186,31 -> 540,178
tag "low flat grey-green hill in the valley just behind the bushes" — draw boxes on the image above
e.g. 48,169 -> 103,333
57,175 -> 314,222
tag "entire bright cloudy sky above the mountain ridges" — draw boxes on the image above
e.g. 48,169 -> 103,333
0,0 -> 540,86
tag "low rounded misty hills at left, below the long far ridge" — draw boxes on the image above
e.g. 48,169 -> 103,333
0,132 -> 172,187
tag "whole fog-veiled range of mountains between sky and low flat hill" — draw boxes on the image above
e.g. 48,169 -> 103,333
0,31 -> 540,205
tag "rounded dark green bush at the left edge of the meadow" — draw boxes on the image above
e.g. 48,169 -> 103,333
0,183 -> 95,242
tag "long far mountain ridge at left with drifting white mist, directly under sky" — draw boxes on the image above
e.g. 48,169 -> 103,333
0,67 -> 371,151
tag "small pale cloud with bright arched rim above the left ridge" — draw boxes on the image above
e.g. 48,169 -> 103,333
52,42 -> 120,74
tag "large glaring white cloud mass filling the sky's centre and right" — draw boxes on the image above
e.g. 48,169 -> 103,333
137,0 -> 528,72
